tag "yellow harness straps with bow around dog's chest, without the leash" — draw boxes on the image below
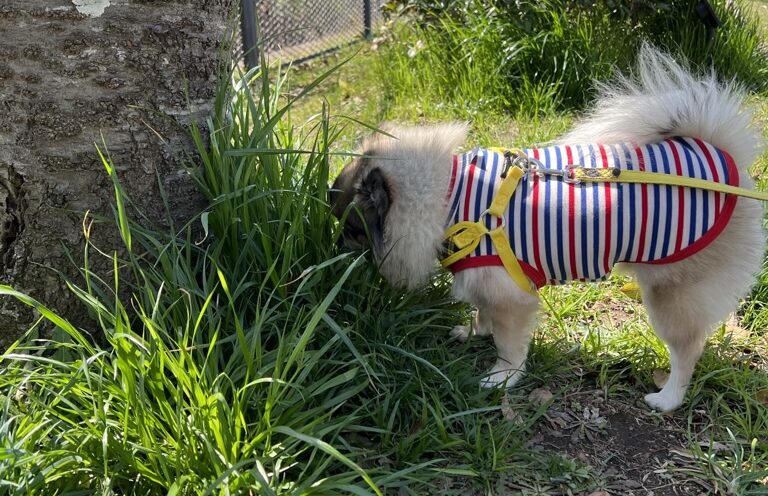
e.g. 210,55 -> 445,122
440,165 -> 536,294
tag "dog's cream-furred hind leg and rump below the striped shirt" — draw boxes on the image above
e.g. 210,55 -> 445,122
628,196 -> 765,411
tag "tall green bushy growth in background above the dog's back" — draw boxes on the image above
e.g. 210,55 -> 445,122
378,0 -> 768,115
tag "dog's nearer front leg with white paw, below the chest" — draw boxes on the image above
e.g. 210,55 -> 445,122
480,303 -> 538,387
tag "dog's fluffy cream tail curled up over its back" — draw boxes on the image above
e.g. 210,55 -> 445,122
559,44 -> 760,170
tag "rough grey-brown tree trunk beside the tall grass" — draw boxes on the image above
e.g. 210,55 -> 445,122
0,0 -> 234,351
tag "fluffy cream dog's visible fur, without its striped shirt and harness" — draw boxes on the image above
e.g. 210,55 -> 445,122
332,47 -> 765,411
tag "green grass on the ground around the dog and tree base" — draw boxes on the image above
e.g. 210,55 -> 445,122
0,1 -> 768,495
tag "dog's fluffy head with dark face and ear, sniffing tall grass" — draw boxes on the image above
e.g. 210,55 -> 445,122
330,124 -> 467,287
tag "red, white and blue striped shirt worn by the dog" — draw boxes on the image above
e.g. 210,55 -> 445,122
446,138 -> 739,287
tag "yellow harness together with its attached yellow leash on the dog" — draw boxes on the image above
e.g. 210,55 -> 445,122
440,148 -> 768,294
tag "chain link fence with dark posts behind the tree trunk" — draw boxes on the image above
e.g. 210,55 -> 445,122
240,0 -> 381,67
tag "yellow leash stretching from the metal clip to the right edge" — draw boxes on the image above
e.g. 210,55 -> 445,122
568,167 -> 768,201
